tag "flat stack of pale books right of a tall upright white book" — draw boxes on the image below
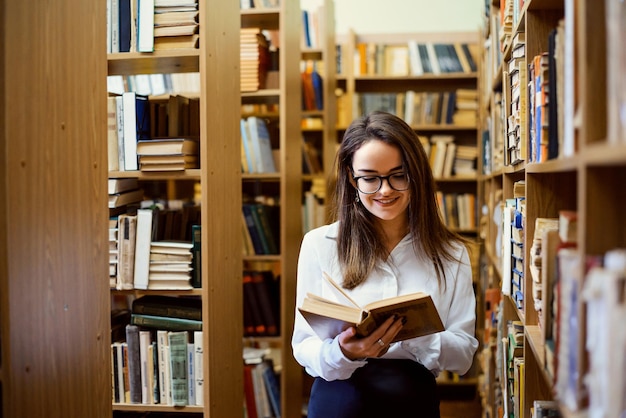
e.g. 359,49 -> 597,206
148,241 -> 193,290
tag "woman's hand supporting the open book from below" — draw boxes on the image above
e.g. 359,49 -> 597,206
337,316 -> 404,360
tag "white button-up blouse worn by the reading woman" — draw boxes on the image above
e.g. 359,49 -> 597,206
292,223 -> 478,380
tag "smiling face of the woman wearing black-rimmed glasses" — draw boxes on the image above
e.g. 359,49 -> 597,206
352,139 -> 410,227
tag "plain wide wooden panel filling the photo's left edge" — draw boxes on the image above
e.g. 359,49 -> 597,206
0,0 -> 111,418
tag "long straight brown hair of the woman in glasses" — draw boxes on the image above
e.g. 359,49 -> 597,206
333,111 -> 465,289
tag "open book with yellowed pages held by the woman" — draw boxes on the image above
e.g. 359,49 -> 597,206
298,273 -> 444,342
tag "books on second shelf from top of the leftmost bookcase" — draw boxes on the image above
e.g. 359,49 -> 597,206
107,92 -> 200,171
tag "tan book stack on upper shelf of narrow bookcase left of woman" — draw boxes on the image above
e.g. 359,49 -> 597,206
240,28 -> 270,92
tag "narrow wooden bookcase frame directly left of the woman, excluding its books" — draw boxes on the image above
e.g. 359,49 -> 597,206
239,1 -> 302,417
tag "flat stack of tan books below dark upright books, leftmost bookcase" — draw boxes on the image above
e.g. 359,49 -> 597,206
137,137 -> 200,171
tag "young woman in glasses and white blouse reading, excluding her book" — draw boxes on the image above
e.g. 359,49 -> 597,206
292,112 -> 478,418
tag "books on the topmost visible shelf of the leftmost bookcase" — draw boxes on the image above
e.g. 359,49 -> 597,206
106,0 -> 199,53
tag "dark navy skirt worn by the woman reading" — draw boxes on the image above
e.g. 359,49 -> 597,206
307,359 -> 439,418
